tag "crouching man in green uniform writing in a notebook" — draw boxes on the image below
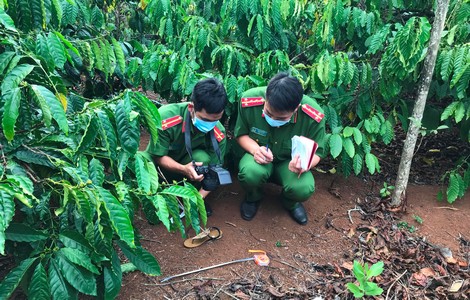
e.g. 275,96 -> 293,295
235,73 -> 325,225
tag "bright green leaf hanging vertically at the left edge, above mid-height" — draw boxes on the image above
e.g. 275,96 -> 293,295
2,88 -> 21,142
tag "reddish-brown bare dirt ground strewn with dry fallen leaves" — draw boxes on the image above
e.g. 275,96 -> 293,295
119,134 -> 470,299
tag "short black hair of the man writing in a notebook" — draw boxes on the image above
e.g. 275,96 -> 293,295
266,72 -> 304,112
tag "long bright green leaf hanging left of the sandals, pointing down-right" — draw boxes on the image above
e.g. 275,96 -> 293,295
98,187 -> 135,248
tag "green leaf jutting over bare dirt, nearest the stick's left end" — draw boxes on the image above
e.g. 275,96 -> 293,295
117,241 -> 161,276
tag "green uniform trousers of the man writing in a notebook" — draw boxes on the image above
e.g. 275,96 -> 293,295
238,153 -> 315,209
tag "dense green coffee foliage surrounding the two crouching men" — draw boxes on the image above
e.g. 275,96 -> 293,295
0,0 -> 470,299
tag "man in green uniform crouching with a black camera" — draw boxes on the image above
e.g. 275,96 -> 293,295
147,78 -> 227,216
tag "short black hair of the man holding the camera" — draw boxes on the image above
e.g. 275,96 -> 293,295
191,78 -> 228,114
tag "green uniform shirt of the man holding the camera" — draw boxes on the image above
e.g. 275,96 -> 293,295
147,102 -> 227,164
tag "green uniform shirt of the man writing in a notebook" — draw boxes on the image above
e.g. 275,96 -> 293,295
235,87 -> 325,162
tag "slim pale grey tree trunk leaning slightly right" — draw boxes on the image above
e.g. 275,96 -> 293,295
391,0 -> 449,206
